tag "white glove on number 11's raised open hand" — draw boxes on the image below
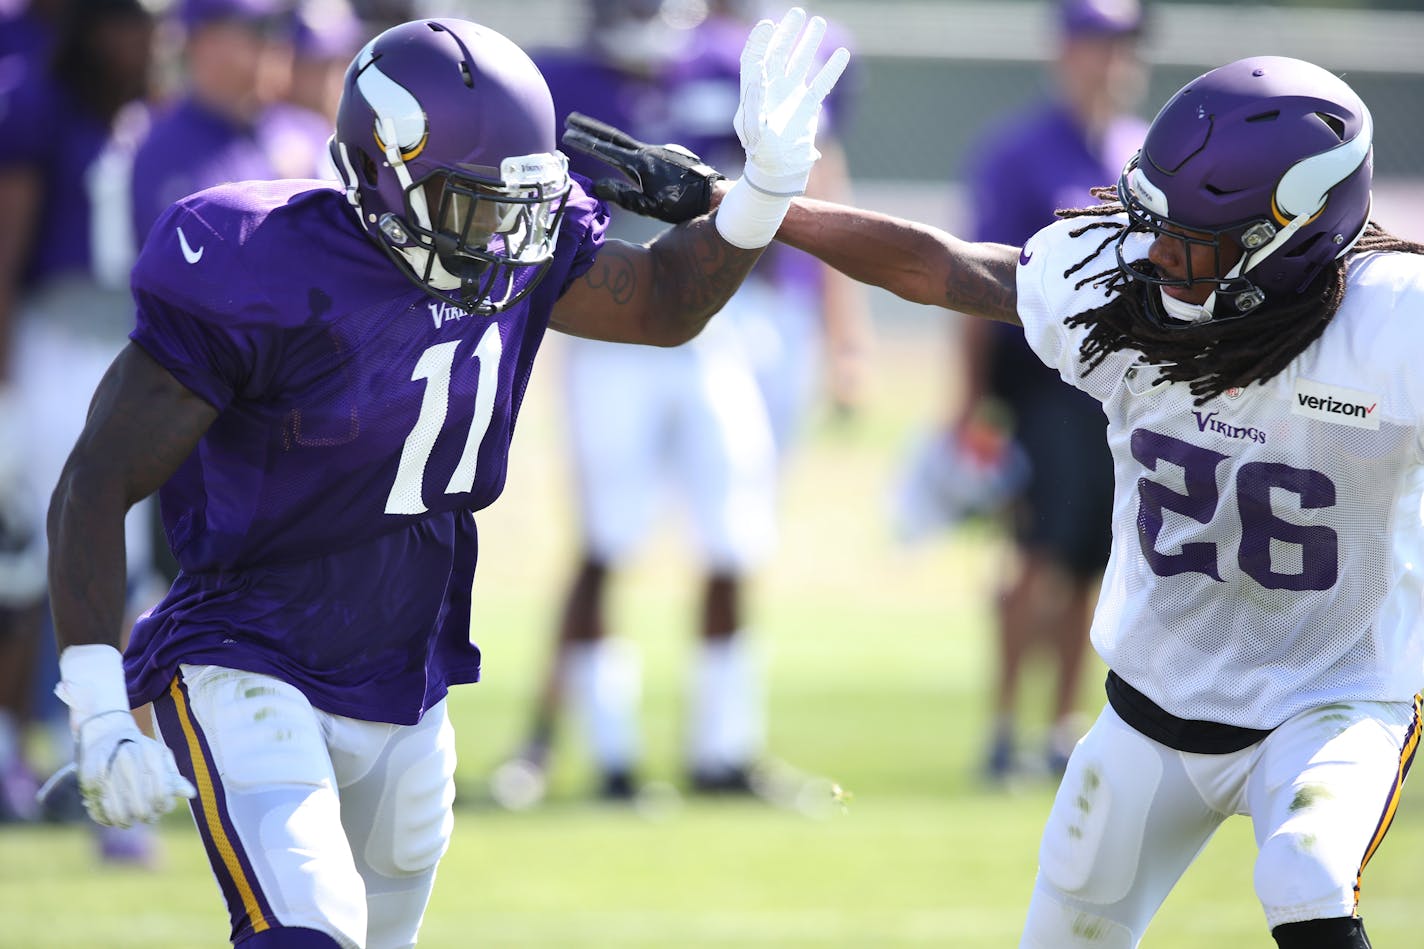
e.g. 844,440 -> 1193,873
716,7 -> 850,249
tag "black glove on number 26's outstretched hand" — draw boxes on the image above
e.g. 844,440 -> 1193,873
564,113 -> 725,224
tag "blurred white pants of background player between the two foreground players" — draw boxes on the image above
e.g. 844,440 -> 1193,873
565,277 -> 778,573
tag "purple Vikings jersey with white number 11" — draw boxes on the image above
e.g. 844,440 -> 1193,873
125,171 -> 608,724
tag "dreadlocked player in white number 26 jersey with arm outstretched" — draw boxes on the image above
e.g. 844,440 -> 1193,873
578,57 -> 1424,949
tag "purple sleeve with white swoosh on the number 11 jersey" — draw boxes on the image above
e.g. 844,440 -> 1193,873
130,204 -> 275,412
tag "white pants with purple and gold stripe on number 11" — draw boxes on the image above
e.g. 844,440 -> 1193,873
154,665 -> 454,949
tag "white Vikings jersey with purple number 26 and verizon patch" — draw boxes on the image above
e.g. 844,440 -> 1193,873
1018,219 -> 1424,728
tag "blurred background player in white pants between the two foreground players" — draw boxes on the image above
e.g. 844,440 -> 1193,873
491,0 -> 869,805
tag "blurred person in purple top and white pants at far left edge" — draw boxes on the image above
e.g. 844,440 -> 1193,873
0,0 -> 154,861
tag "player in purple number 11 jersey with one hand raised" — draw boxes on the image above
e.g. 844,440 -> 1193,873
48,9 -> 846,949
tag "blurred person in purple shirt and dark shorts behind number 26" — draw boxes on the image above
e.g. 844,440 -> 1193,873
946,0 -> 1146,781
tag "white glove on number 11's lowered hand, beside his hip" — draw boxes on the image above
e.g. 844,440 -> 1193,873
54,644 -> 197,826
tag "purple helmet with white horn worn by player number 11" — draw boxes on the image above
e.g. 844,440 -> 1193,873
330,20 -> 570,313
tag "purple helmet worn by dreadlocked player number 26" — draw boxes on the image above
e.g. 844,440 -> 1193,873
1118,56 -> 1374,325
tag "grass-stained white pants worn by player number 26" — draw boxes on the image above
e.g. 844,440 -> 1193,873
1020,700 -> 1420,949
